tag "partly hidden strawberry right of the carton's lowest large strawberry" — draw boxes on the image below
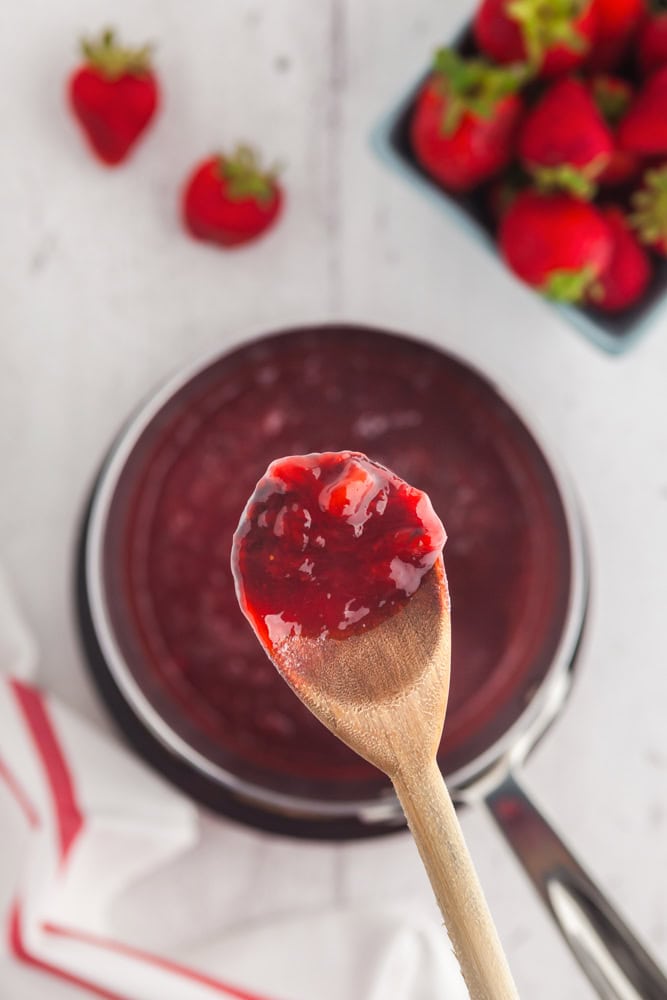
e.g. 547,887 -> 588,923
589,206 -> 652,313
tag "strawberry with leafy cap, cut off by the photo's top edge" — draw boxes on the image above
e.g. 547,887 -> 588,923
473,0 -> 595,77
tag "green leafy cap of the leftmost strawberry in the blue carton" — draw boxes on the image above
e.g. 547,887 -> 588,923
433,49 -> 529,135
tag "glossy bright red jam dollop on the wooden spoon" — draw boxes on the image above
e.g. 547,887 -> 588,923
232,451 -> 446,650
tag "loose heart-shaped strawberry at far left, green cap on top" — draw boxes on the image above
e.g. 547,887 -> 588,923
69,30 -> 159,166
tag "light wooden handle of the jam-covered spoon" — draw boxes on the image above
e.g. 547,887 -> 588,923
393,761 -> 519,1000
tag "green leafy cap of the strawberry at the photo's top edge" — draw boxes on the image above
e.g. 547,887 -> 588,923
506,0 -> 588,69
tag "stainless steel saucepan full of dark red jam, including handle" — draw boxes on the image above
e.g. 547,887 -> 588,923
77,325 -> 667,1000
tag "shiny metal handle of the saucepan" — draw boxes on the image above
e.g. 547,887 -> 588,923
486,775 -> 667,1000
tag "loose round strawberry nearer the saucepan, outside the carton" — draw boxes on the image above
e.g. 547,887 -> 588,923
183,146 -> 283,247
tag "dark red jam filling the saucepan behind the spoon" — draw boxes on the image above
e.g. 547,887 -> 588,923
104,327 -> 570,795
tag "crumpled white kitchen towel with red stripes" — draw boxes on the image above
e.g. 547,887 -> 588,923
0,579 -> 467,1000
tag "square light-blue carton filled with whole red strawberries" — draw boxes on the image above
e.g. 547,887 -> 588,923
373,0 -> 667,353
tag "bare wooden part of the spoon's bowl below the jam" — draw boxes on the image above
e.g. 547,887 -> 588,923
271,559 -> 450,780
